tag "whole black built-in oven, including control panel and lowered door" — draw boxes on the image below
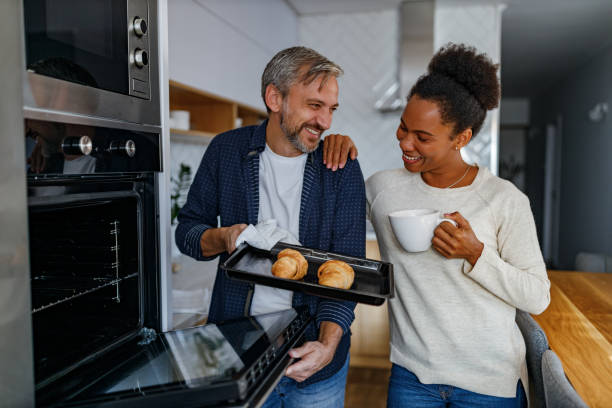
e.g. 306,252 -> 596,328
24,115 -> 311,407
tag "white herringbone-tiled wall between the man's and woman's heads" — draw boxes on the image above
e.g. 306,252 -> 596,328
299,10 -> 403,178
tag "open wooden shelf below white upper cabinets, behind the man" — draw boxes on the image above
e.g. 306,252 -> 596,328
169,80 -> 268,143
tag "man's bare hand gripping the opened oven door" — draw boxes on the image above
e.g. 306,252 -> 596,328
285,322 -> 342,382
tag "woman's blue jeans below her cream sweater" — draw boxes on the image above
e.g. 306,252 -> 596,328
387,364 -> 527,408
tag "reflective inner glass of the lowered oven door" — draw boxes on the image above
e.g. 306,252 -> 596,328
53,309 -> 298,405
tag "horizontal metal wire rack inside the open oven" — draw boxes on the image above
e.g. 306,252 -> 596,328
32,272 -> 138,314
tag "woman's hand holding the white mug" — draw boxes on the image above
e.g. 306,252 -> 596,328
431,212 -> 484,266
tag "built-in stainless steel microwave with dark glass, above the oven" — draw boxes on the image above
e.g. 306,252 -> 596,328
23,0 -> 160,125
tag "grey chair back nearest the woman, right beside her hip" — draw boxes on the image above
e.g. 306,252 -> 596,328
515,310 -> 554,408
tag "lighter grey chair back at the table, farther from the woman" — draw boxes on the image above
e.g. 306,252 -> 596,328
542,350 -> 588,408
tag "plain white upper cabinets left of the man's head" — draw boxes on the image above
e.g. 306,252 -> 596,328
168,0 -> 298,109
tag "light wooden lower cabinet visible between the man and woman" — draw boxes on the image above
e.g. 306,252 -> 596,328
350,241 -> 391,368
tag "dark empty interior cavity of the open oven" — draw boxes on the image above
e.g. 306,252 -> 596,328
29,192 -> 141,383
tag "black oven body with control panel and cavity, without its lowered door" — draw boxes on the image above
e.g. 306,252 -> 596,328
24,114 -> 162,389
